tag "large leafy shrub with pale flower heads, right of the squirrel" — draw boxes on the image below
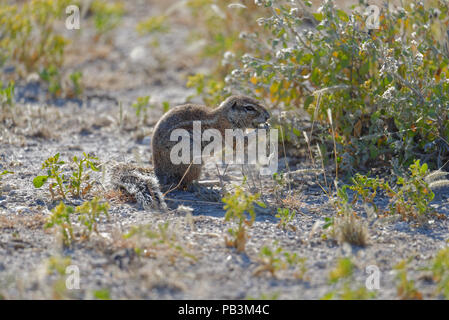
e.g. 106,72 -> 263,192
222,0 -> 449,171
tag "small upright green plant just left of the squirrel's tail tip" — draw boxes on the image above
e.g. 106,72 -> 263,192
68,152 -> 99,197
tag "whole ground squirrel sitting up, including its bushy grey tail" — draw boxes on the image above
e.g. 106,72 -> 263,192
110,96 -> 270,210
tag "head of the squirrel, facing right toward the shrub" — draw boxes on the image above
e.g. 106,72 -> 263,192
220,96 -> 270,129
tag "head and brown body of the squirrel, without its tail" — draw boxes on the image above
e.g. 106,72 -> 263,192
152,95 -> 270,187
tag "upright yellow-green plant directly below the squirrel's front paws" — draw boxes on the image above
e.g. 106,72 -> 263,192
222,186 -> 265,252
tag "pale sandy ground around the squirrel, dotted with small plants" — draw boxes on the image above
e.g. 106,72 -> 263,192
0,1 -> 449,299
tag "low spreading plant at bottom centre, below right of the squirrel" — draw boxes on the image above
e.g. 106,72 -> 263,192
254,243 -> 307,279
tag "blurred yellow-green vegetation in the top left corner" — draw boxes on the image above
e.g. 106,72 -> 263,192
0,0 -> 124,98
